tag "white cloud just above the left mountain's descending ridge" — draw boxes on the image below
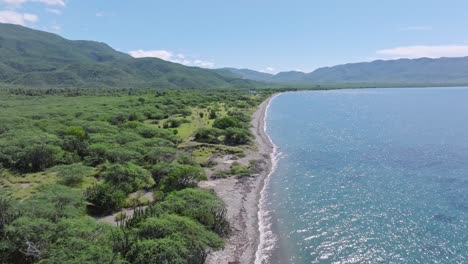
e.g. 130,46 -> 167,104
128,50 -> 215,68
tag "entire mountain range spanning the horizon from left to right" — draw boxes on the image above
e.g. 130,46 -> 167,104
0,23 -> 468,88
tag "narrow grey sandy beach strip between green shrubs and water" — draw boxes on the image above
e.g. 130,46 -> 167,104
200,94 -> 276,264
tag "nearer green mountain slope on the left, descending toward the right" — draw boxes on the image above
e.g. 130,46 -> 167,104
0,23 -> 253,88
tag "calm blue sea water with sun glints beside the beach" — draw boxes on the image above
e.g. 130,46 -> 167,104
265,88 -> 468,263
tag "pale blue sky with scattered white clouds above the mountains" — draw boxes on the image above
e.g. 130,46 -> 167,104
0,0 -> 468,73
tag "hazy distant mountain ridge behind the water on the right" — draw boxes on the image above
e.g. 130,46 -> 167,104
224,57 -> 468,84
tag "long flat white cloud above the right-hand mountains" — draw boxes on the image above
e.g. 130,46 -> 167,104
377,45 -> 468,59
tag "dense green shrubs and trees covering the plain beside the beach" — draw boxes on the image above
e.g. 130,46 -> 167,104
0,89 -> 270,263
